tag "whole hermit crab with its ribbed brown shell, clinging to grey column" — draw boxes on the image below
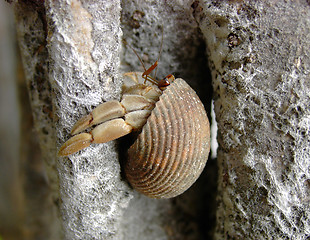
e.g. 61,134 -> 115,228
59,46 -> 210,198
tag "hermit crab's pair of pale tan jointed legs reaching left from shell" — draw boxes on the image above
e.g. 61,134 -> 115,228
58,87 -> 157,156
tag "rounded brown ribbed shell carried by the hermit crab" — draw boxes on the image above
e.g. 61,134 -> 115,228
125,78 -> 210,198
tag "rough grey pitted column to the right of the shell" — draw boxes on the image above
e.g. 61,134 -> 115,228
195,1 -> 310,239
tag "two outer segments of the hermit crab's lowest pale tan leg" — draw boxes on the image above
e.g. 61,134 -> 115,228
58,118 -> 132,157
